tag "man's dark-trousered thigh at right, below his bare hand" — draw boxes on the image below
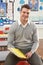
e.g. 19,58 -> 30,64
29,53 -> 42,65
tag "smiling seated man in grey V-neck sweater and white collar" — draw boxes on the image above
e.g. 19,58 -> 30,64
5,4 -> 42,65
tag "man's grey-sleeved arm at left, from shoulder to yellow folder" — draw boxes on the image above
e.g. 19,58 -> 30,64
8,22 -> 17,48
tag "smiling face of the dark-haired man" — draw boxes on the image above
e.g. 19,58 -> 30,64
20,8 -> 30,21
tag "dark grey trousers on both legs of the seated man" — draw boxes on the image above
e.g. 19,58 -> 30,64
4,53 -> 43,65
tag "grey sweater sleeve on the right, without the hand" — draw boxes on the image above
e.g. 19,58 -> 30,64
31,26 -> 39,53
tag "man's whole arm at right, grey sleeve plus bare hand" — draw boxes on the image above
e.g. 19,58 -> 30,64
26,23 -> 39,58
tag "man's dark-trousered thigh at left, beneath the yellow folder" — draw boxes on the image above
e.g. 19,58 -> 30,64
4,53 -> 20,65
